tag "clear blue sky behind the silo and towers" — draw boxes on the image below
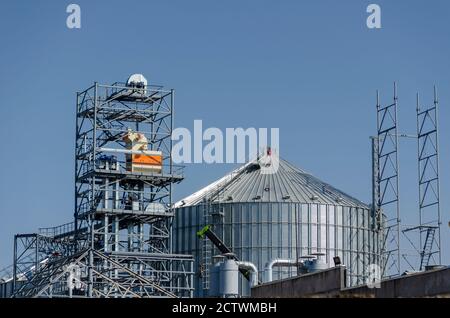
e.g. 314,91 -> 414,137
0,0 -> 450,267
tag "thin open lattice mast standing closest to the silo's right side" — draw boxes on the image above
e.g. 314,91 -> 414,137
375,83 -> 400,277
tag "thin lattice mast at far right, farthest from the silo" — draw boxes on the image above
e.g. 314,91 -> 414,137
403,87 -> 441,270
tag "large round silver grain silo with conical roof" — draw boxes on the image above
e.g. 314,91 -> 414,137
173,155 -> 379,297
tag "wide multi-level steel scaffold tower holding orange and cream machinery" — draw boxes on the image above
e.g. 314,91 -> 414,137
10,77 -> 193,298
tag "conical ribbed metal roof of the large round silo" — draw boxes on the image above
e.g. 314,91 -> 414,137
175,158 -> 369,208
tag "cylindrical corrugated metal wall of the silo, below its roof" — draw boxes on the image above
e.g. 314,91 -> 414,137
173,202 -> 380,297
